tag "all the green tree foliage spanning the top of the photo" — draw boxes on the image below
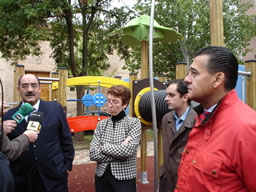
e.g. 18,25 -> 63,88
0,0 -> 256,78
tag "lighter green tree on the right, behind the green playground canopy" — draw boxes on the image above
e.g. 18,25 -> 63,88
114,0 -> 256,78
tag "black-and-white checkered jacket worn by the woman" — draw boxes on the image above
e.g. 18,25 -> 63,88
90,116 -> 141,180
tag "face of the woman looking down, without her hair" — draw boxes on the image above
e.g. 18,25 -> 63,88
107,94 -> 127,116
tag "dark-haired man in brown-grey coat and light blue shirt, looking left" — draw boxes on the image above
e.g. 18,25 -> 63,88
159,79 -> 197,192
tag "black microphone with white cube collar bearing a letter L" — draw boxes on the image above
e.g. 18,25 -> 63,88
27,111 -> 44,133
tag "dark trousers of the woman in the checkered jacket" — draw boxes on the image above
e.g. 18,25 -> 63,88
95,165 -> 136,192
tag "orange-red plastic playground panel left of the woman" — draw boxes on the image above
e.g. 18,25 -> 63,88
67,116 -> 109,133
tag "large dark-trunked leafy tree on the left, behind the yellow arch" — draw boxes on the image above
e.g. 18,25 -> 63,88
0,0 -> 130,141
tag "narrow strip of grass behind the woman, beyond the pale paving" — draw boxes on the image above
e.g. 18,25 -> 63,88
73,129 -> 154,150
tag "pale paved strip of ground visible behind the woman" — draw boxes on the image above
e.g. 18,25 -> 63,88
73,141 -> 154,165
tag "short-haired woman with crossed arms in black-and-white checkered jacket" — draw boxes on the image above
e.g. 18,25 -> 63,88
90,85 -> 141,192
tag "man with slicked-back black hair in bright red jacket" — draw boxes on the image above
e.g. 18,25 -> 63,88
175,47 -> 256,192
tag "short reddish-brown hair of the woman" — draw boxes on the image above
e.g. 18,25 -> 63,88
107,85 -> 131,105
